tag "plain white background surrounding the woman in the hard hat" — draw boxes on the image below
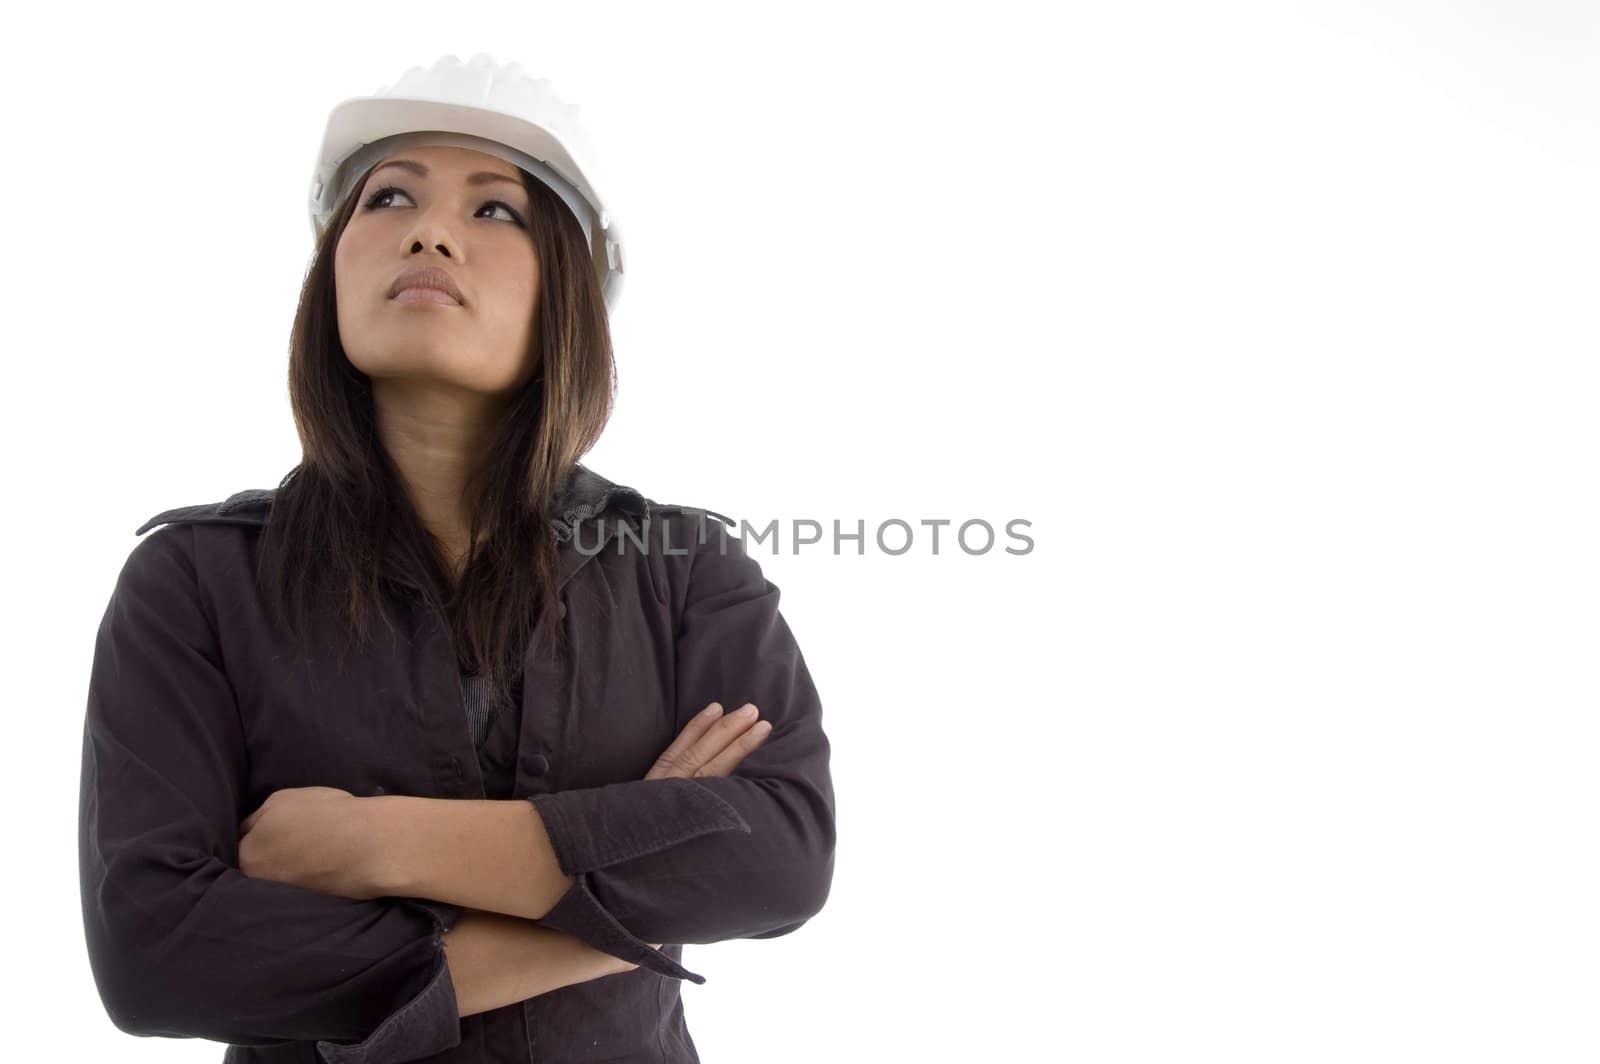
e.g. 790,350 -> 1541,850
0,0 -> 1600,1064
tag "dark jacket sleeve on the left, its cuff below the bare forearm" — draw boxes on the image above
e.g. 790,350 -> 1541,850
78,526 -> 461,1064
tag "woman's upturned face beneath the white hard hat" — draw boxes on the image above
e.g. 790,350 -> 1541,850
333,146 -> 539,395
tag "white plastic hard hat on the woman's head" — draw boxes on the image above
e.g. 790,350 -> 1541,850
310,53 -> 622,310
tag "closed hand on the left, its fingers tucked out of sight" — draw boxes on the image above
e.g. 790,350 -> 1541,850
238,787 -> 384,901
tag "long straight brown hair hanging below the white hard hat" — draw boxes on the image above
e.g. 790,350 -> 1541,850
258,163 -> 616,701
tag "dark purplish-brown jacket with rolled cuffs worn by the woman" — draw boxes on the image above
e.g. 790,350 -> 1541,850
78,466 -> 834,1064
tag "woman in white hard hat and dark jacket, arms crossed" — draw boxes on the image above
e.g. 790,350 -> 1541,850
80,56 -> 834,1064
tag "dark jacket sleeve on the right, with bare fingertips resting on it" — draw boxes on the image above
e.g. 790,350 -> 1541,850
528,505 -> 834,982
